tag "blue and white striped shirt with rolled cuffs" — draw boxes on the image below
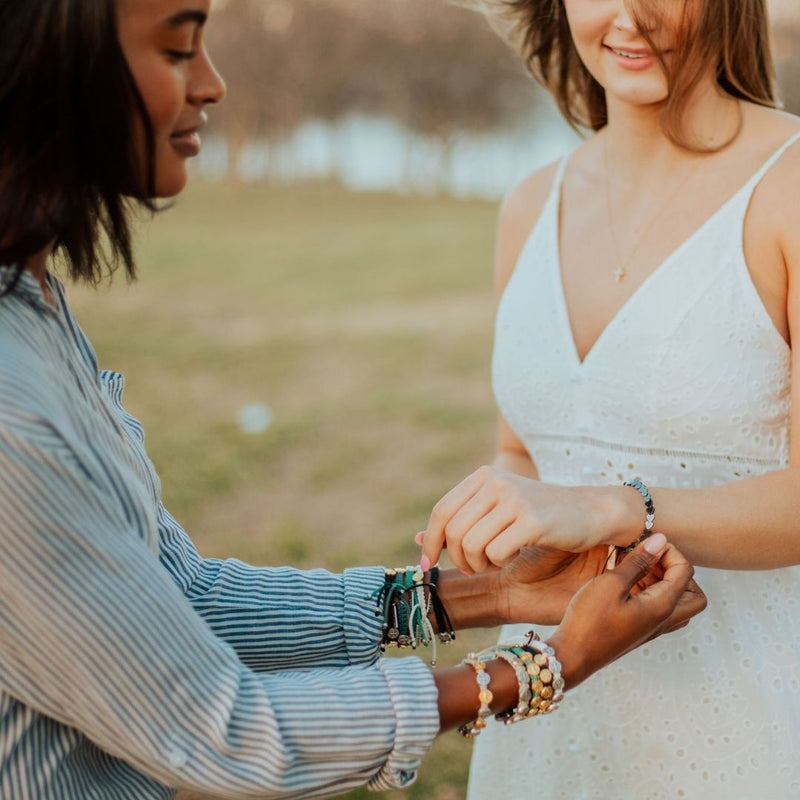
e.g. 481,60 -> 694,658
0,270 -> 438,800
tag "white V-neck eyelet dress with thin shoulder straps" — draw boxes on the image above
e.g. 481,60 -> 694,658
468,134 -> 800,800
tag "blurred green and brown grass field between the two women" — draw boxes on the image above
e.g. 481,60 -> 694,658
71,185 -> 506,800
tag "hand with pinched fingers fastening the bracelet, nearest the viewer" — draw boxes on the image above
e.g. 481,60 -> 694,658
549,533 -> 707,687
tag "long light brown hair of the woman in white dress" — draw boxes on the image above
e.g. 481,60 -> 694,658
483,0 -> 777,151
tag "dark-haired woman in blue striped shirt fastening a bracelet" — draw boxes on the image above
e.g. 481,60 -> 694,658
0,0 -> 704,800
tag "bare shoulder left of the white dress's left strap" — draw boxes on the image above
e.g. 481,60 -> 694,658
494,156 -> 559,295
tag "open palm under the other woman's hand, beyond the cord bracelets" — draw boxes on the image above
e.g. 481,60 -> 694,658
500,545 -> 612,625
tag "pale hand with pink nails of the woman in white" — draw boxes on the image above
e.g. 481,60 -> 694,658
422,467 -> 603,572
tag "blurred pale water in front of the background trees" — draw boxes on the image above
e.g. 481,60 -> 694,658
197,112 -> 579,199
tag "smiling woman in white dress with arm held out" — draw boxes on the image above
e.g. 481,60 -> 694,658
422,0 -> 800,800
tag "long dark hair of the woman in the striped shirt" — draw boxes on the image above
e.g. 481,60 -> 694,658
0,0 -> 155,293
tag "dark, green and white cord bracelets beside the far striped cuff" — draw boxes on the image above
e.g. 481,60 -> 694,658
368,566 -> 456,666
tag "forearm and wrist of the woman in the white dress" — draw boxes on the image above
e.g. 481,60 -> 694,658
586,467 -> 800,570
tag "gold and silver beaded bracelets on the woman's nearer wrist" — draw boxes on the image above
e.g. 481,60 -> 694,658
459,631 -> 564,739
